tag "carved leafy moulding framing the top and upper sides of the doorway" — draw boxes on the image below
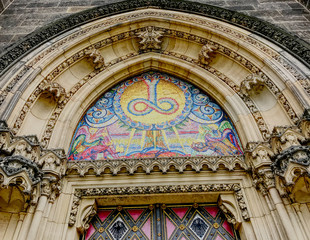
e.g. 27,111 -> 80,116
68,183 -> 250,227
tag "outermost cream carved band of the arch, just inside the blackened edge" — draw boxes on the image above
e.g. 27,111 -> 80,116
0,9 -> 309,114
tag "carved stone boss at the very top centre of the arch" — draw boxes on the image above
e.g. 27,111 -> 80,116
137,26 -> 164,51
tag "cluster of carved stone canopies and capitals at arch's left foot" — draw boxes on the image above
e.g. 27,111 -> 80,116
0,121 -> 67,204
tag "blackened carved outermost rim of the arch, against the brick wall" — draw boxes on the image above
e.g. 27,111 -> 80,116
0,0 -> 310,76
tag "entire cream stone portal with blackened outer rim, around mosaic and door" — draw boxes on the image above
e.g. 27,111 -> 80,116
0,0 -> 310,239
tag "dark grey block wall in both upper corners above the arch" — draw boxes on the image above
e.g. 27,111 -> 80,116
0,0 -> 310,53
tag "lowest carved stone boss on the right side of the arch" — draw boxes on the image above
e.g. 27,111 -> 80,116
240,72 -> 266,96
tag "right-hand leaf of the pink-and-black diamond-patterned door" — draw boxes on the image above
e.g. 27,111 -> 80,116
162,204 -> 239,240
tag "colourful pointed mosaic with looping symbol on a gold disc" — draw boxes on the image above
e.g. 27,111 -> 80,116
68,72 -> 243,160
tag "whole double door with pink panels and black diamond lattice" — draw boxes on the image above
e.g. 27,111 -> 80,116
81,204 -> 240,240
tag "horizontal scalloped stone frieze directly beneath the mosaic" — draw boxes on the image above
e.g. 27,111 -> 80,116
68,156 -> 247,176
